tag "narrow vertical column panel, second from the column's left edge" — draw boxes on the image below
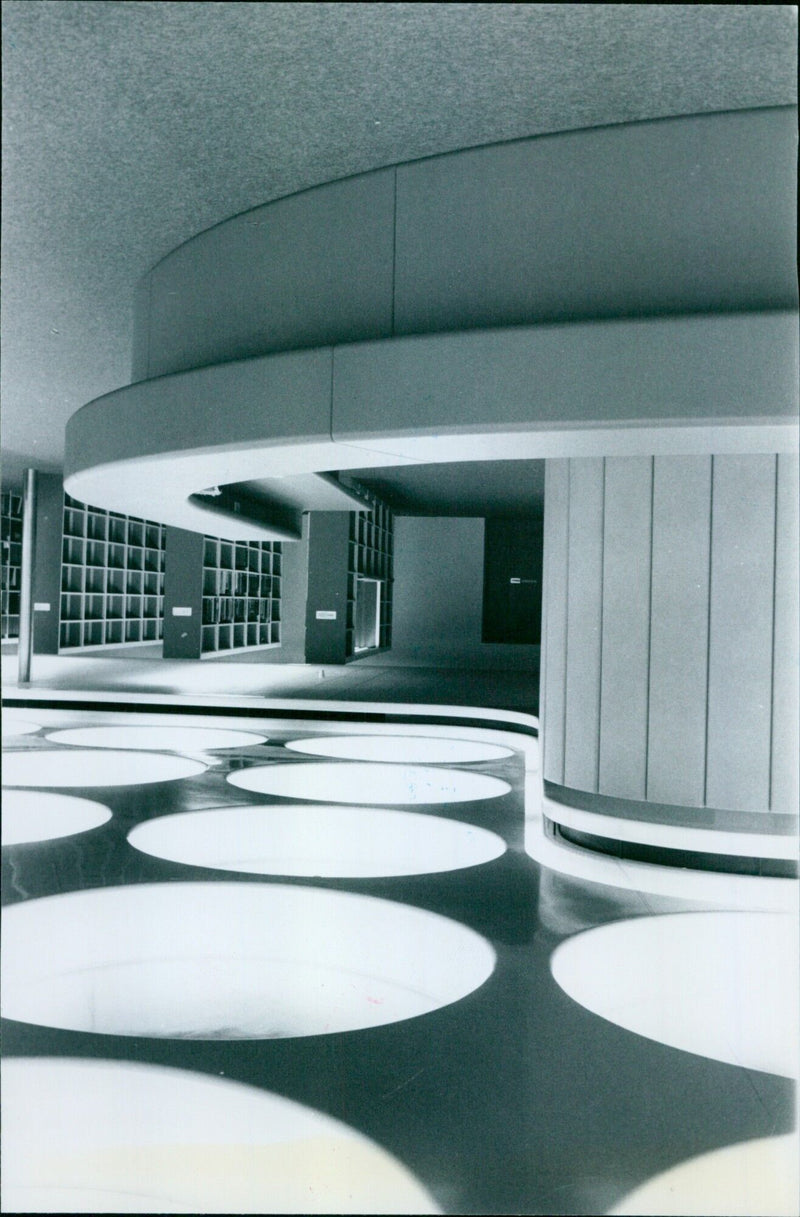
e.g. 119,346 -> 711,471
564,458 -> 604,791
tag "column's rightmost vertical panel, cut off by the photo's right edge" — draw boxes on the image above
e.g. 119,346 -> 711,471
770,455 -> 800,815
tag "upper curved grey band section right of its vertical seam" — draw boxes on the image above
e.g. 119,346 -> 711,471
395,111 -> 796,338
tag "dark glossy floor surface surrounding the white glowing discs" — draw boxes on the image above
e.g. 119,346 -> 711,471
2,707 -> 794,1215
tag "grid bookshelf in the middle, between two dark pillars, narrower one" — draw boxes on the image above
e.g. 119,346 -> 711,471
201,537 -> 282,655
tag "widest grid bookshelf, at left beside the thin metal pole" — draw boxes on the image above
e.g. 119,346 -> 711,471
58,494 -> 166,650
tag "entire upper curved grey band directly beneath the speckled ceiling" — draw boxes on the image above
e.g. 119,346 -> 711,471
133,108 -> 796,380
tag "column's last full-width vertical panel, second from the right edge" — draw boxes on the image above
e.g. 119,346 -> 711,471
706,456 -> 777,811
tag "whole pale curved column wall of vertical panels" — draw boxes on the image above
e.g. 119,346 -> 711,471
543,455 -> 799,814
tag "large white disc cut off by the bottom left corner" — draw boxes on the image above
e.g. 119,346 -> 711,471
1,1056 -> 438,1213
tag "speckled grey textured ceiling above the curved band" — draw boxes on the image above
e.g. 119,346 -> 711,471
2,0 -> 796,482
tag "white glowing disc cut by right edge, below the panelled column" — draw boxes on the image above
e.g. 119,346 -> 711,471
550,913 -> 799,1077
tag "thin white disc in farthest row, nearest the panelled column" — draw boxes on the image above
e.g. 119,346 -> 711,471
286,735 -> 514,764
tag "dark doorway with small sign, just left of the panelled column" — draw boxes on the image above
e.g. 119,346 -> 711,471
481,517 -> 543,645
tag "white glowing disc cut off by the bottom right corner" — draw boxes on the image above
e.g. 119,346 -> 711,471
609,1133 -> 800,1217
